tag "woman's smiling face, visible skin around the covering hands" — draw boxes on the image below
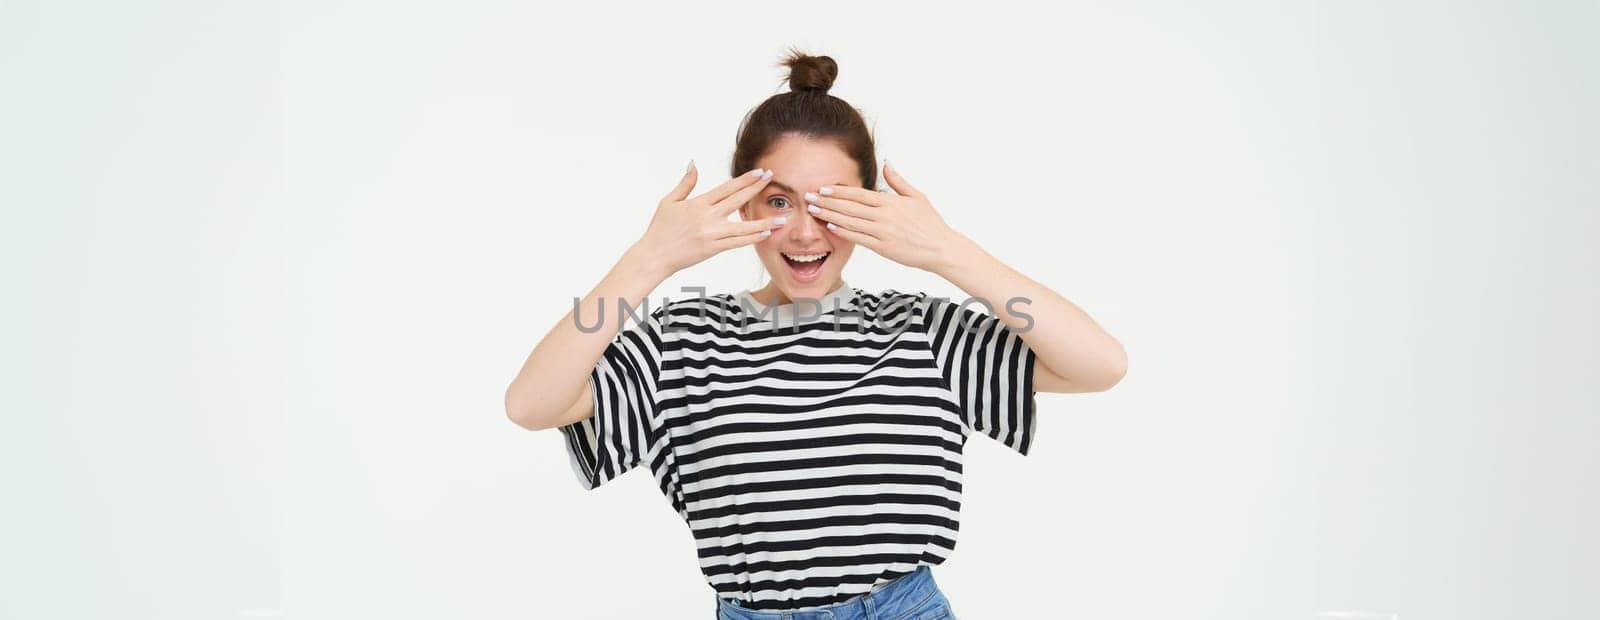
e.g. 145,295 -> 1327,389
739,134 -> 861,302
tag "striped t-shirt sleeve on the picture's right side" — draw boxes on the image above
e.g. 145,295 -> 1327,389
923,297 -> 1037,454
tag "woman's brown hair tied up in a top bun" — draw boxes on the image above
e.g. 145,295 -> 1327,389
731,48 -> 878,190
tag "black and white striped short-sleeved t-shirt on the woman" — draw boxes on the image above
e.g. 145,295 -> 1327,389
562,283 -> 1035,610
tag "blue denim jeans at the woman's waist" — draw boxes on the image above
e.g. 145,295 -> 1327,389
717,564 -> 955,620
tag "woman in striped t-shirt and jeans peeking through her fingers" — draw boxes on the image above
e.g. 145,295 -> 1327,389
506,53 -> 1126,620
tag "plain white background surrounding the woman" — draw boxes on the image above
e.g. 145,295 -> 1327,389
0,0 -> 1600,620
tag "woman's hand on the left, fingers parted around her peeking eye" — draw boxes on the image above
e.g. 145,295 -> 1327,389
634,165 -> 786,275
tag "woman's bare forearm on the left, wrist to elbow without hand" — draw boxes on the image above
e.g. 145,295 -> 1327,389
506,244 -> 670,430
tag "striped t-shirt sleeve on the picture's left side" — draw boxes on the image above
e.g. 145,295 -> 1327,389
560,303 -> 667,489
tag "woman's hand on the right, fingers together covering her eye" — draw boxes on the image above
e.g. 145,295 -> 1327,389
805,165 -> 970,273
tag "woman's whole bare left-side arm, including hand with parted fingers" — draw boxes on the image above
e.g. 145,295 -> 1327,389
506,165 -> 781,430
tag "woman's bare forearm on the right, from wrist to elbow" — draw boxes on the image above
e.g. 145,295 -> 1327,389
933,236 -> 1128,388
